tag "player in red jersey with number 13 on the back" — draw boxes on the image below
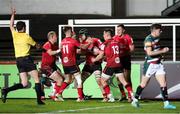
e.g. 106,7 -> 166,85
94,29 -> 134,102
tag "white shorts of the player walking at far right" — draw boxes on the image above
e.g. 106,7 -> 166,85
144,63 -> 166,77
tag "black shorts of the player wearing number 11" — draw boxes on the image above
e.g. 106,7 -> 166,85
63,65 -> 80,74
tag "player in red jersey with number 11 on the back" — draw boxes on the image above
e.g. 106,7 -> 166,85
56,26 -> 89,102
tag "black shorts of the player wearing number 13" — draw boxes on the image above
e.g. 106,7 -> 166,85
103,67 -> 123,76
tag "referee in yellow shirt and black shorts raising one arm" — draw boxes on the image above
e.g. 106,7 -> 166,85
1,9 -> 45,105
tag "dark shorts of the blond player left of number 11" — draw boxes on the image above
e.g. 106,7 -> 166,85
40,63 -> 61,77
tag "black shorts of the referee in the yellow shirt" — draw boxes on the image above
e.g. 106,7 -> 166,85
16,56 -> 37,73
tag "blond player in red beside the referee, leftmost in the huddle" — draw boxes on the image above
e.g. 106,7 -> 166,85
41,31 -> 64,101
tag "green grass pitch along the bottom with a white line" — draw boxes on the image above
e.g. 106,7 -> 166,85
0,99 -> 180,114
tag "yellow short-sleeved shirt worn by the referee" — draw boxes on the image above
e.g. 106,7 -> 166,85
12,30 -> 36,58
